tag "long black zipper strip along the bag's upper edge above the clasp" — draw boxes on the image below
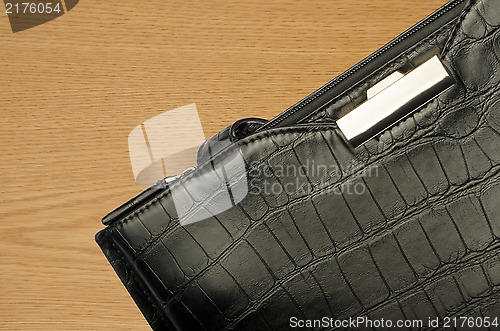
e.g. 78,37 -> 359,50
259,0 -> 465,131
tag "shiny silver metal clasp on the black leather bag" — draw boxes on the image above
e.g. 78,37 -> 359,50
337,55 -> 454,147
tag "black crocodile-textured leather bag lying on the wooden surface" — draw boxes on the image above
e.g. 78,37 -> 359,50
96,0 -> 500,330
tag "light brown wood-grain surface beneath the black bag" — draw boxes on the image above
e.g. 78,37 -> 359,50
0,0 -> 445,330
